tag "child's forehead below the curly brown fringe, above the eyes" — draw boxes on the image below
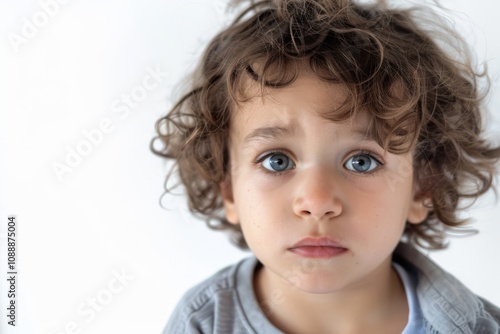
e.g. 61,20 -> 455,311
230,70 -> 369,136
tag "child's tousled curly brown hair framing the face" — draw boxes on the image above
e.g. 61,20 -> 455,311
151,0 -> 500,249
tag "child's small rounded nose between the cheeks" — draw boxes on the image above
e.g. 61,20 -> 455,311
293,169 -> 343,220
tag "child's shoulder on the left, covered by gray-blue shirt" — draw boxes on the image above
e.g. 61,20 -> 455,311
164,257 -> 258,334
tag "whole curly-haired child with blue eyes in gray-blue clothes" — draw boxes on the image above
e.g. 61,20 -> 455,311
155,0 -> 500,334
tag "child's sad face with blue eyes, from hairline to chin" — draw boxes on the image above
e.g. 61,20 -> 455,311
221,73 -> 427,293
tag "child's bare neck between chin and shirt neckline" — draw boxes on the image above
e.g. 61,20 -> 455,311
254,259 -> 408,333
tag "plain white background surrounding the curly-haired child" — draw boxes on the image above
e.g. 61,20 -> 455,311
0,0 -> 500,334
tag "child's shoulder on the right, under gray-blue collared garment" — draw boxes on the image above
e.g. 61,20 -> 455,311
394,243 -> 500,333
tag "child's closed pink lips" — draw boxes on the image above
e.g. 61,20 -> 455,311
288,238 -> 347,259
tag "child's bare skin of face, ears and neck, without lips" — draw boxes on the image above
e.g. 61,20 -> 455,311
221,70 -> 427,333
